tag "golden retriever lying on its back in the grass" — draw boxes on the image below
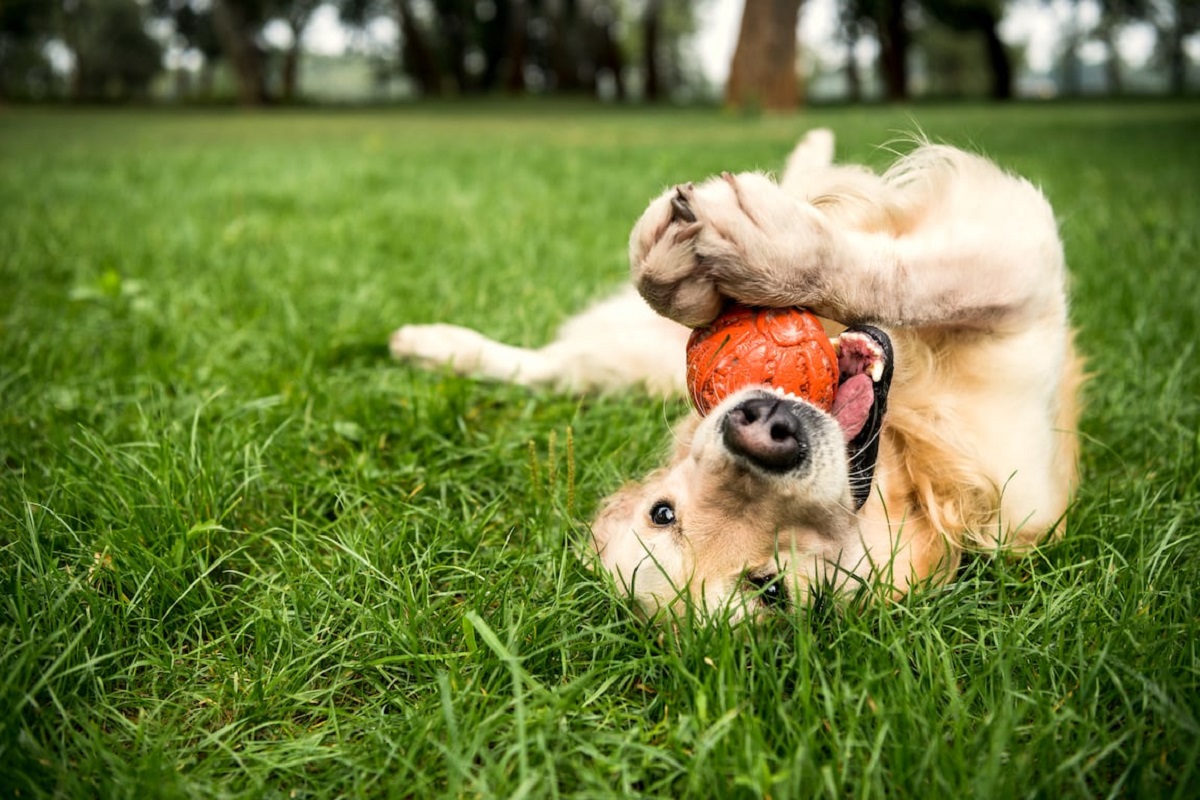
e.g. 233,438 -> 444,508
391,130 -> 1082,620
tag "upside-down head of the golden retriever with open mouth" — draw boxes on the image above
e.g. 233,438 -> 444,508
592,326 -> 893,619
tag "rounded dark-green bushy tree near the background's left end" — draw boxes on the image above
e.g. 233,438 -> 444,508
58,0 -> 162,101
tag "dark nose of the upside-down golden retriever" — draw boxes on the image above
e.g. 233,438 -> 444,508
724,397 -> 809,473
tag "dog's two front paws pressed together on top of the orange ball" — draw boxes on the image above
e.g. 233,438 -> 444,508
630,173 -> 829,327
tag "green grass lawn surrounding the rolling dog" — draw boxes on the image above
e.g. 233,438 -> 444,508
0,103 -> 1200,799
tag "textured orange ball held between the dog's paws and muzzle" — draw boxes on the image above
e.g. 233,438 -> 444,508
688,303 -> 838,416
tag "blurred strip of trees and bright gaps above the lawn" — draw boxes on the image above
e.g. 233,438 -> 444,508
0,0 -> 1200,110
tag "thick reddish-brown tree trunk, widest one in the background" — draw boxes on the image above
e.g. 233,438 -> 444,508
725,0 -> 800,110
